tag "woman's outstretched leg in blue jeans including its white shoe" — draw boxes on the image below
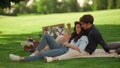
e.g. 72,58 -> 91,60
9,47 -> 68,61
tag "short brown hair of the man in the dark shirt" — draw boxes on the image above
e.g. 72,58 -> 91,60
80,14 -> 94,24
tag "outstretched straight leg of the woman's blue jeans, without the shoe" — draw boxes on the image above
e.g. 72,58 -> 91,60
22,47 -> 68,61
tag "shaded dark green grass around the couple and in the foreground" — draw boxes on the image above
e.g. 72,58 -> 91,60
0,25 -> 120,68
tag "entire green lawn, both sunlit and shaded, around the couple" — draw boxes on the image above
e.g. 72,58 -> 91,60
0,9 -> 120,68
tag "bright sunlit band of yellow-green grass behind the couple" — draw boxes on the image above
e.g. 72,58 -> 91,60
0,9 -> 120,34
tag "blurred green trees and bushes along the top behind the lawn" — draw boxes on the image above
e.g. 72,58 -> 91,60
0,0 -> 120,15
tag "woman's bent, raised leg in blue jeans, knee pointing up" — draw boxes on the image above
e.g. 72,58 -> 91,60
34,34 -> 60,55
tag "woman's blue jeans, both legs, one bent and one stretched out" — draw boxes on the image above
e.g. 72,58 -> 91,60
25,34 -> 68,61
